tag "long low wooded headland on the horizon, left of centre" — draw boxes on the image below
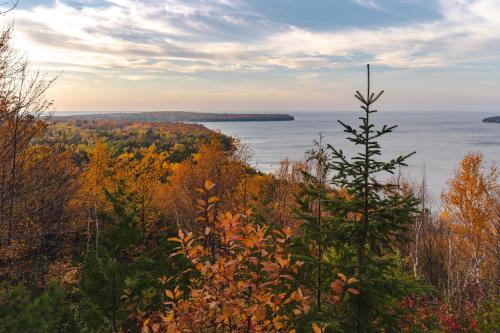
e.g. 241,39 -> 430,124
54,111 -> 294,122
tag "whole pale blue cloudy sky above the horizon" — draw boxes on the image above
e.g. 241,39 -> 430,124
0,0 -> 500,112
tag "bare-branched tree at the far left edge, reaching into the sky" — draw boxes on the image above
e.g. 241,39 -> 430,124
0,26 -> 54,243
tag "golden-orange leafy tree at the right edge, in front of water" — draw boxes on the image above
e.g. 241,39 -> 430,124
442,153 -> 500,303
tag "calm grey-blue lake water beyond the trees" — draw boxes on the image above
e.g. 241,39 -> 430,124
204,112 -> 500,196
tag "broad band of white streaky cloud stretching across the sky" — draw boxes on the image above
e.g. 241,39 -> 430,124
3,0 -> 500,76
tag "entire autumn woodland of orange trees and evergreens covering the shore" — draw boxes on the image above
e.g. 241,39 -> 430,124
0,29 -> 500,333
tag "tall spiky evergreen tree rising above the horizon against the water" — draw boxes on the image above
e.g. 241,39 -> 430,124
327,65 -> 417,332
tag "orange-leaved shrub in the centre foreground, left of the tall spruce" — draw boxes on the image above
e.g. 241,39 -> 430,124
144,181 -> 308,332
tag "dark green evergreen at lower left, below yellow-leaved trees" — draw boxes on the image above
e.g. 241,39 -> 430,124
82,182 -> 142,332
